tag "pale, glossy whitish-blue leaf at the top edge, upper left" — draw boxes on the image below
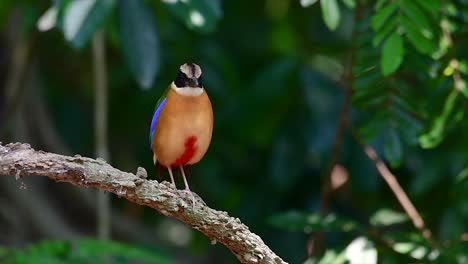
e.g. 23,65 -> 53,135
63,0 -> 115,49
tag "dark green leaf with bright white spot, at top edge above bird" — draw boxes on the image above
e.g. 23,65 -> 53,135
163,0 -> 223,33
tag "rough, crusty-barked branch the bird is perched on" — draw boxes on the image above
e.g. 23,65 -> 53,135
0,143 -> 286,263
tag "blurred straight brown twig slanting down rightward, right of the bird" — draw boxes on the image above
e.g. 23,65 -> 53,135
351,129 -> 433,243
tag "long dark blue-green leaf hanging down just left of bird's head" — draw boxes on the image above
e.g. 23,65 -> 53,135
118,0 -> 159,89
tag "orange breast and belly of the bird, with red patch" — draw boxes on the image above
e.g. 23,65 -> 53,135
153,89 -> 213,167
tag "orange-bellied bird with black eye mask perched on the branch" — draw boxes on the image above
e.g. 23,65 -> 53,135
150,63 -> 213,203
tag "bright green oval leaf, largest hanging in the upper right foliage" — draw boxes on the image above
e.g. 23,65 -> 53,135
380,32 -> 405,76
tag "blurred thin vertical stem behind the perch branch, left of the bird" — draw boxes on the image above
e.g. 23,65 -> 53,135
93,30 -> 111,240
